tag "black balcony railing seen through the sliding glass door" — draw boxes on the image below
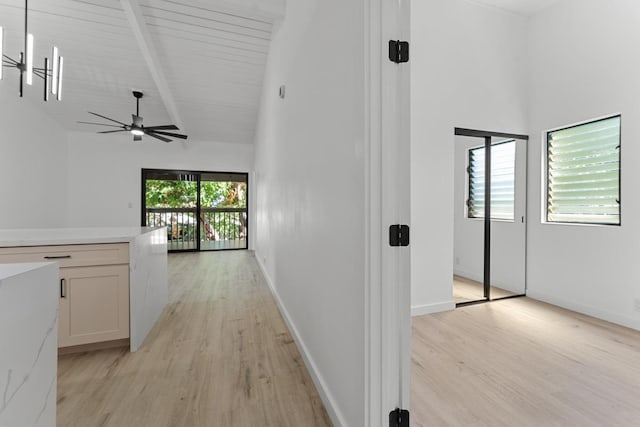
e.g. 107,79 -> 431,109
146,208 -> 247,251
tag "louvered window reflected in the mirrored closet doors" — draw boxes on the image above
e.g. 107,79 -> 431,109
467,140 -> 516,221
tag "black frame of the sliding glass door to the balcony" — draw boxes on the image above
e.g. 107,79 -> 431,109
140,169 -> 251,252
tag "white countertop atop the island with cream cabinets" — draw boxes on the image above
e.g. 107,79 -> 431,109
0,227 -> 161,248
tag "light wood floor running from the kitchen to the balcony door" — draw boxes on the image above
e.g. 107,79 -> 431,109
58,251 -> 331,427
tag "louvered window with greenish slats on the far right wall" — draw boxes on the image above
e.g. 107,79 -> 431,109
547,116 -> 620,225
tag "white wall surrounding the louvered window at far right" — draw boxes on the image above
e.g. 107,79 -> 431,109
528,0 -> 640,329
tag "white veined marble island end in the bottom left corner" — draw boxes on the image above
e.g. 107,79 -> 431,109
0,262 -> 58,427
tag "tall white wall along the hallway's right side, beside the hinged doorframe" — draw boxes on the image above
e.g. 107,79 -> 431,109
255,0 -> 365,426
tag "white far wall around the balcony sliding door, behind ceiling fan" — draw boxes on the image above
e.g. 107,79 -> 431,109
65,132 -> 253,231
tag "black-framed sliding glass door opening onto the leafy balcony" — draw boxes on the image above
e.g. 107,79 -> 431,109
141,169 -> 249,252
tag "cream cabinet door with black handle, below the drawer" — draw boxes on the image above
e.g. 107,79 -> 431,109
58,265 -> 129,347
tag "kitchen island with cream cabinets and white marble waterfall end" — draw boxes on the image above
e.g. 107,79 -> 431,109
0,227 -> 169,351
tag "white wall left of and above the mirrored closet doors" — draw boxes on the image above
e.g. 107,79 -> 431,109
411,0 -> 528,314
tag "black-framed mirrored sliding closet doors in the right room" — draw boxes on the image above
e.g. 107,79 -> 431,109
453,128 -> 529,307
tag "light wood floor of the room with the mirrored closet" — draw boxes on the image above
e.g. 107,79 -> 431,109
411,298 -> 640,427
